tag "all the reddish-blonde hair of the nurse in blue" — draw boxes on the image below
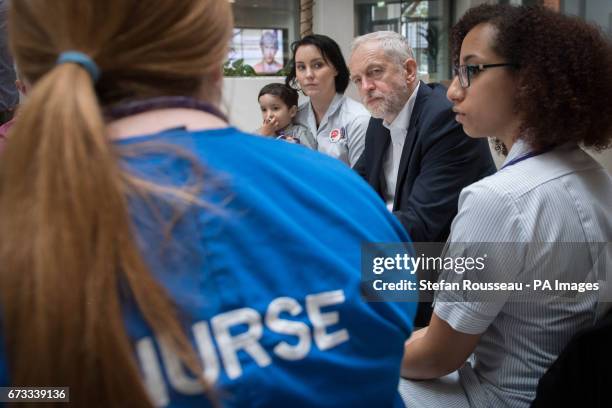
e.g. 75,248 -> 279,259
0,0 -> 232,407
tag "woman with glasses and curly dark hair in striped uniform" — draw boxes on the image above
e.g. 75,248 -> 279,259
400,5 -> 612,407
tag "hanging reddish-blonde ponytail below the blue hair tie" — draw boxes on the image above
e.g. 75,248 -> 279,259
0,64 -> 202,407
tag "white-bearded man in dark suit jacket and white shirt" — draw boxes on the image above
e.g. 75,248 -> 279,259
349,31 -> 496,326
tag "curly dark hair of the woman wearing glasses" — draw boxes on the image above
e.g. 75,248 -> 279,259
451,5 -> 612,150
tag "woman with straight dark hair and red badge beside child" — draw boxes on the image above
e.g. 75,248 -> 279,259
285,34 -> 370,166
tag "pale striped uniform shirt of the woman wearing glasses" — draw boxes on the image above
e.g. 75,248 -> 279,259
434,141 -> 612,407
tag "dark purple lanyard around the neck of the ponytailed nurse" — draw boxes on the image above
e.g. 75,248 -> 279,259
104,96 -> 228,122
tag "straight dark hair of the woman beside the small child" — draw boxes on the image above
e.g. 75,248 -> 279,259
285,34 -> 350,93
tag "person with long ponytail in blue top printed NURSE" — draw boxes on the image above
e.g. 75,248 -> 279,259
0,0 -> 414,407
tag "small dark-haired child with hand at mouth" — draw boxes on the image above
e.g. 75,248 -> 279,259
256,83 -> 317,150
